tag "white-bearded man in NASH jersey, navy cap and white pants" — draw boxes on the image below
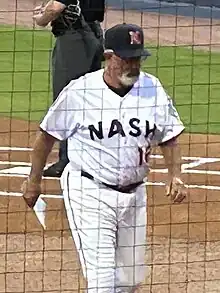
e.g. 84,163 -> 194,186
22,24 -> 186,293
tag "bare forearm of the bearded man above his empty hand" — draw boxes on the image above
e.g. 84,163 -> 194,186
161,139 -> 182,177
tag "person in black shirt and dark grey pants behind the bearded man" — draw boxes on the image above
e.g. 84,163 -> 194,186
34,0 -> 105,177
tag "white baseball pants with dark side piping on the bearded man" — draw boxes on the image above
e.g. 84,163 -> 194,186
61,167 -> 146,293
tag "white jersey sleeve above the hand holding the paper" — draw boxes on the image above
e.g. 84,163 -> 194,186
40,87 -> 79,140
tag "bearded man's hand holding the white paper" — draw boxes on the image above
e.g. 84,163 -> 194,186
21,179 -> 41,209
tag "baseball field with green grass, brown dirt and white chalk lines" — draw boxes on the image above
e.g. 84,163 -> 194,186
0,0 -> 220,293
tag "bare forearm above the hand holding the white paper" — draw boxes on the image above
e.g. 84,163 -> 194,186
30,132 -> 55,183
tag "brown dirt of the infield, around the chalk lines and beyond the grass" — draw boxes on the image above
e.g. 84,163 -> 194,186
0,0 -> 220,293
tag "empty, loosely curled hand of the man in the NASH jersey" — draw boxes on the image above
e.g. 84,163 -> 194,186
166,177 -> 187,203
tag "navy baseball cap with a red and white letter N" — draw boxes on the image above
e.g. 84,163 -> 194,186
104,23 -> 151,58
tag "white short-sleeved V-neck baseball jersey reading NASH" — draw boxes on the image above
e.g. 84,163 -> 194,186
40,69 -> 184,185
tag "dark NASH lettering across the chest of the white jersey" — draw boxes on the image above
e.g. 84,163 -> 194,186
88,118 -> 156,140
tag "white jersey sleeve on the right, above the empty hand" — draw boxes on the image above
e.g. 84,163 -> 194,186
151,80 -> 185,144
